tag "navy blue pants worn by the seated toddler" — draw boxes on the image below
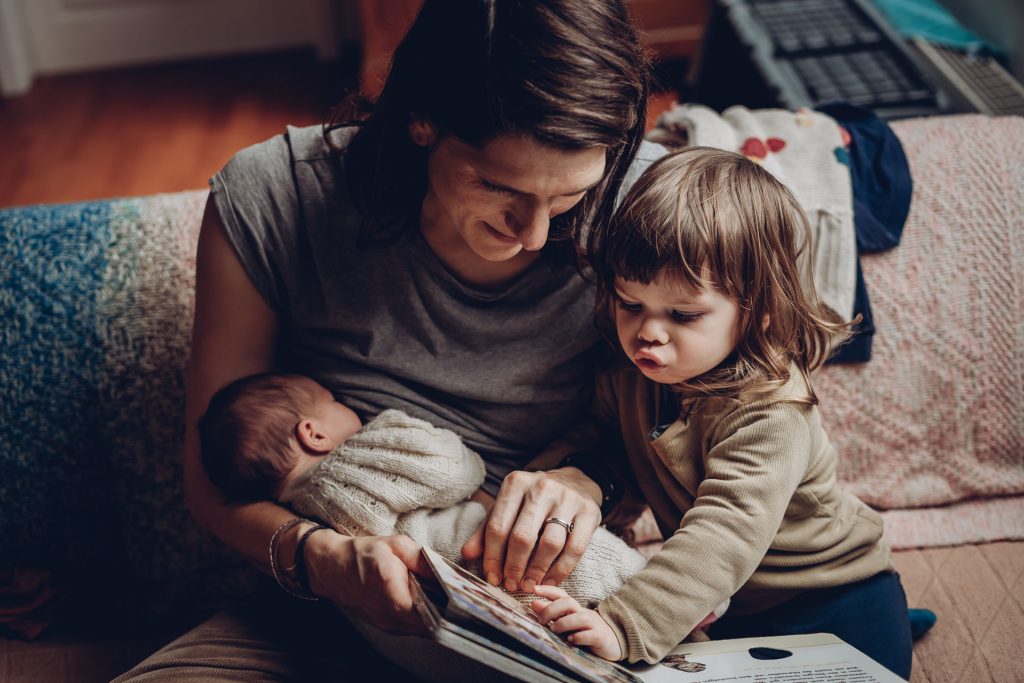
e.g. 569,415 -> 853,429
709,572 -> 910,679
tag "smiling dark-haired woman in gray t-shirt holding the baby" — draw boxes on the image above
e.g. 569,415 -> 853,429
116,0 -> 657,680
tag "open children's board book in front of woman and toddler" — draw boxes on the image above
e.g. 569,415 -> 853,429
410,547 -> 902,683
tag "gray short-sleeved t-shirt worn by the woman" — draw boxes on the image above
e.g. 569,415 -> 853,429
210,126 -> 664,494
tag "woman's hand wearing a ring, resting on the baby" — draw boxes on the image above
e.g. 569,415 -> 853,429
462,467 -> 601,593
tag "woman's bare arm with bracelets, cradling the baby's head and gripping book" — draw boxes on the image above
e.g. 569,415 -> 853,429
184,196 -> 426,632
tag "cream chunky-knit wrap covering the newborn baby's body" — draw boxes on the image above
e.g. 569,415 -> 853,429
282,411 -> 646,605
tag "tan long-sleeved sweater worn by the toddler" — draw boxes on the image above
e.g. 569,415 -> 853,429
531,368 -> 893,663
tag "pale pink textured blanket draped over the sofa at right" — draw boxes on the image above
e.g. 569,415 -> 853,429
815,116 -> 1024,548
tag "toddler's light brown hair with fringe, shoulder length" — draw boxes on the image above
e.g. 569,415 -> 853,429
588,147 -> 850,403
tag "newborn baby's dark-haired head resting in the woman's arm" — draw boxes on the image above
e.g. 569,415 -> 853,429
198,373 -> 360,503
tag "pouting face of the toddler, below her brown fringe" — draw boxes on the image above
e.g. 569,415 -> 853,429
615,275 -> 739,384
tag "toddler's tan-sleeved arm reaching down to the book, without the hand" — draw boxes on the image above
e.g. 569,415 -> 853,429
597,400 -> 812,663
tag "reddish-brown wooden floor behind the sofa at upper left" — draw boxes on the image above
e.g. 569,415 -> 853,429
0,51 -> 355,208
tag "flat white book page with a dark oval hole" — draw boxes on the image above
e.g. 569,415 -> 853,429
634,634 -> 903,683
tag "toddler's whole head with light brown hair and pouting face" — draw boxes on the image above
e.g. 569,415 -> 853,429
589,147 -> 843,400
